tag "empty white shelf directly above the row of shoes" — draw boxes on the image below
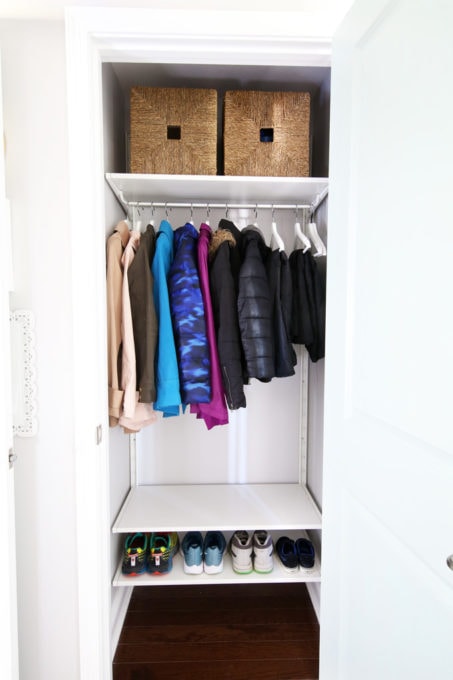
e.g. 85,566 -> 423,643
112,484 -> 321,533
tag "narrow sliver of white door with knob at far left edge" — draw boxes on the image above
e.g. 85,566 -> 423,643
0,51 -> 19,680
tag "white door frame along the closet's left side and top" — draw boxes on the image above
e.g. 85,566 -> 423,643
66,8 -> 336,680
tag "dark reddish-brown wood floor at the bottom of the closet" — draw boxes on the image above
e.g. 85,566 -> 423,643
113,583 -> 319,680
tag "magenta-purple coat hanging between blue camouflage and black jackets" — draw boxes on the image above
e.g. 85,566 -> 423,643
190,224 -> 228,430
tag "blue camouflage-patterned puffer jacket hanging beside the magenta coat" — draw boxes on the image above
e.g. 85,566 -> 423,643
168,222 -> 211,404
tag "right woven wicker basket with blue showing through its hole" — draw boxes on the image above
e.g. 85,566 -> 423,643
223,90 -> 310,177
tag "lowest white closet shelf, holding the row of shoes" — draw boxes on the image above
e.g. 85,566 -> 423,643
113,531 -> 321,587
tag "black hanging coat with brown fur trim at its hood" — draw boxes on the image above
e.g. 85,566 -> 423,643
209,220 -> 247,410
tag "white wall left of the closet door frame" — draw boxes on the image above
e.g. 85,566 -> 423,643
0,21 -> 78,680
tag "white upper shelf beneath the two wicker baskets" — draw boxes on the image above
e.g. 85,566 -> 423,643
106,173 -> 328,208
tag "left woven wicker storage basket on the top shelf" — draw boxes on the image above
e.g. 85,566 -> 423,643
129,87 -> 217,175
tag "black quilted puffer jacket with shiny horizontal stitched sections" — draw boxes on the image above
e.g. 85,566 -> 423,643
238,226 -> 275,382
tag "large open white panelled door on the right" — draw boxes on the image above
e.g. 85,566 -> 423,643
320,0 -> 453,680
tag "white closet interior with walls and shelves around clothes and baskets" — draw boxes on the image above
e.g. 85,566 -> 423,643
102,62 -> 330,602
